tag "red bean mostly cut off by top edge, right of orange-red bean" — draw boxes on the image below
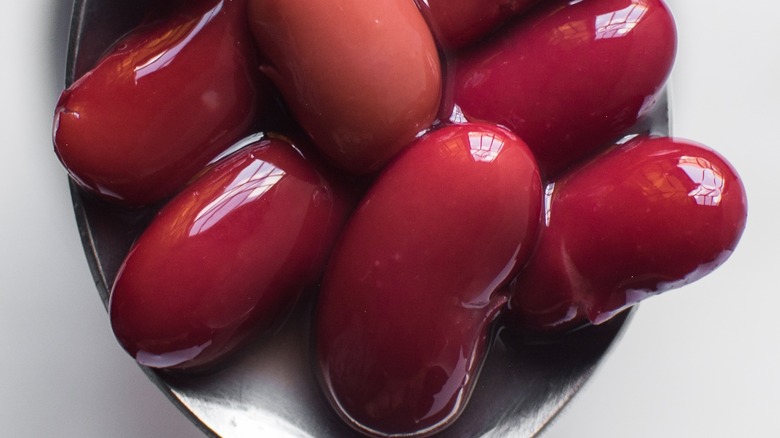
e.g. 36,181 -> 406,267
417,0 -> 543,49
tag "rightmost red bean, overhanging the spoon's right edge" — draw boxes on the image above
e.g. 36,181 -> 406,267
510,137 -> 747,331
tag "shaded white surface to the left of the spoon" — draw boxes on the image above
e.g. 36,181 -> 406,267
0,0 -> 203,438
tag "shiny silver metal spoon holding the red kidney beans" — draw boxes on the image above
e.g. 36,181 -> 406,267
66,0 -> 669,438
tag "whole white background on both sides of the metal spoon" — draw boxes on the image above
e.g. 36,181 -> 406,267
0,0 -> 780,438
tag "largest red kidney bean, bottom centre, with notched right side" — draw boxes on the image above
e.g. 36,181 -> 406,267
316,124 -> 542,436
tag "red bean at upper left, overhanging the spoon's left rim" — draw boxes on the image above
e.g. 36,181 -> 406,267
54,0 -> 273,205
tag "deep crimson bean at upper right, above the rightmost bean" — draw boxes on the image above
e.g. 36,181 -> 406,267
455,0 -> 676,175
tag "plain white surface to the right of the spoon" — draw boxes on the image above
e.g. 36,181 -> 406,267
543,0 -> 780,438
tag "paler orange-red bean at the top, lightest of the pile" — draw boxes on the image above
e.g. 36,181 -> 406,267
249,0 -> 441,174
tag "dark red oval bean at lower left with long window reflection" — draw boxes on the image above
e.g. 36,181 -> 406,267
110,139 -> 350,370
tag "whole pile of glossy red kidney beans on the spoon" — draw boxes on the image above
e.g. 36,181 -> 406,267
54,0 -> 746,436
